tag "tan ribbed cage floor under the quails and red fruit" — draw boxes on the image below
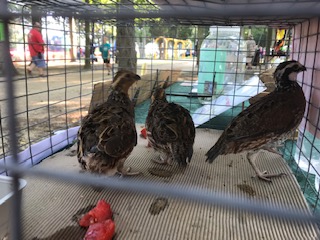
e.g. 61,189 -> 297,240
22,126 -> 317,240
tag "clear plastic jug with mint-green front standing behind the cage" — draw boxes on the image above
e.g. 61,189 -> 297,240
198,27 -> 246,103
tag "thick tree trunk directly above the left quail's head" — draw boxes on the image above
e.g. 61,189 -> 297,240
117,0 -> 137,72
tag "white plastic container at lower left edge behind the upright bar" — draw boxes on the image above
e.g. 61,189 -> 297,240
0,176 -> 27,239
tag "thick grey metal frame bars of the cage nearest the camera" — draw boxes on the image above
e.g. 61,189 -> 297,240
0,0 -> 320,240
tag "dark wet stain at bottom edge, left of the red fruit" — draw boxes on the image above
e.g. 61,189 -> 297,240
32,226 -> 86,240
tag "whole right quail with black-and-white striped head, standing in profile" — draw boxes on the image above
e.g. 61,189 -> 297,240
206,60 -> 306,181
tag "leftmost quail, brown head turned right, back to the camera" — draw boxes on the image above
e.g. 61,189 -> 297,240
77,70 -> 140,175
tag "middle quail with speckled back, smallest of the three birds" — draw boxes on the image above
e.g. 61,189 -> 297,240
146,80 -> 195,166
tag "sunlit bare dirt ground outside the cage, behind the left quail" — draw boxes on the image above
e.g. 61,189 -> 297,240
0,60 -> 195,157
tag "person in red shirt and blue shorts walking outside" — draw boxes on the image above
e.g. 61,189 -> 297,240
28,22 -> 46,77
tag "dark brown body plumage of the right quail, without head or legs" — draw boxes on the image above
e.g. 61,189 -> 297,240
207,83 -> 305,162
